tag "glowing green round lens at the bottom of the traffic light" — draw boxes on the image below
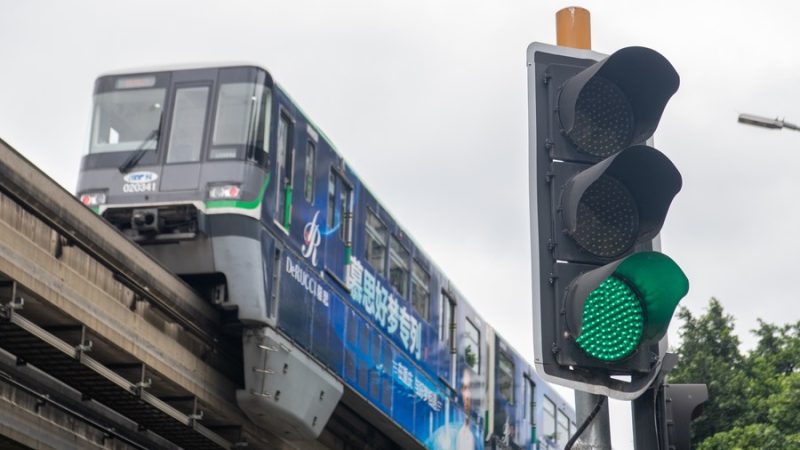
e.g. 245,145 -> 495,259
576,276 -> 644,361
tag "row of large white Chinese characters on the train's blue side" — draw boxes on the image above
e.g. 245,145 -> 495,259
347,257 -> 422,359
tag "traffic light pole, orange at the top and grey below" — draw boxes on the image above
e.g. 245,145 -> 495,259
556,7 -> 611,450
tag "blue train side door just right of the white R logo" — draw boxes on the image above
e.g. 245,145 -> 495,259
324,166 -> 353,285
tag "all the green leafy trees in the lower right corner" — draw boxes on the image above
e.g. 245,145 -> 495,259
669,298 -> 800,450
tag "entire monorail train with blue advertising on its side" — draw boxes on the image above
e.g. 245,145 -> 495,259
77,65 -> 575,449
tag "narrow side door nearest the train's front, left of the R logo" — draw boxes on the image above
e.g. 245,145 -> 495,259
274,108 -> 294,229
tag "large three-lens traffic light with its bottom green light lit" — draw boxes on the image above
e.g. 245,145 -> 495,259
528,43 -> 689,399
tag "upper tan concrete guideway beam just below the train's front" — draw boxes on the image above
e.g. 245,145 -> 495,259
0,141 -> 293,449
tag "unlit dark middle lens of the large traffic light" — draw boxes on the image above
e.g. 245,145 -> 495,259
573,175 -> 639,258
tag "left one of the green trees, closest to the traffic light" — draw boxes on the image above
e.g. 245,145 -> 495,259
669,298 -> 749,443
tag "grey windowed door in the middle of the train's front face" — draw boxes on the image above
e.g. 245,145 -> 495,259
160,70 -> 216,192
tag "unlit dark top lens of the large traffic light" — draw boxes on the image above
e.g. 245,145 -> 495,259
569,77 -> 634,158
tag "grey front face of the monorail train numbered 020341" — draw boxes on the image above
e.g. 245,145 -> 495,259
77,66 -> 273,323
